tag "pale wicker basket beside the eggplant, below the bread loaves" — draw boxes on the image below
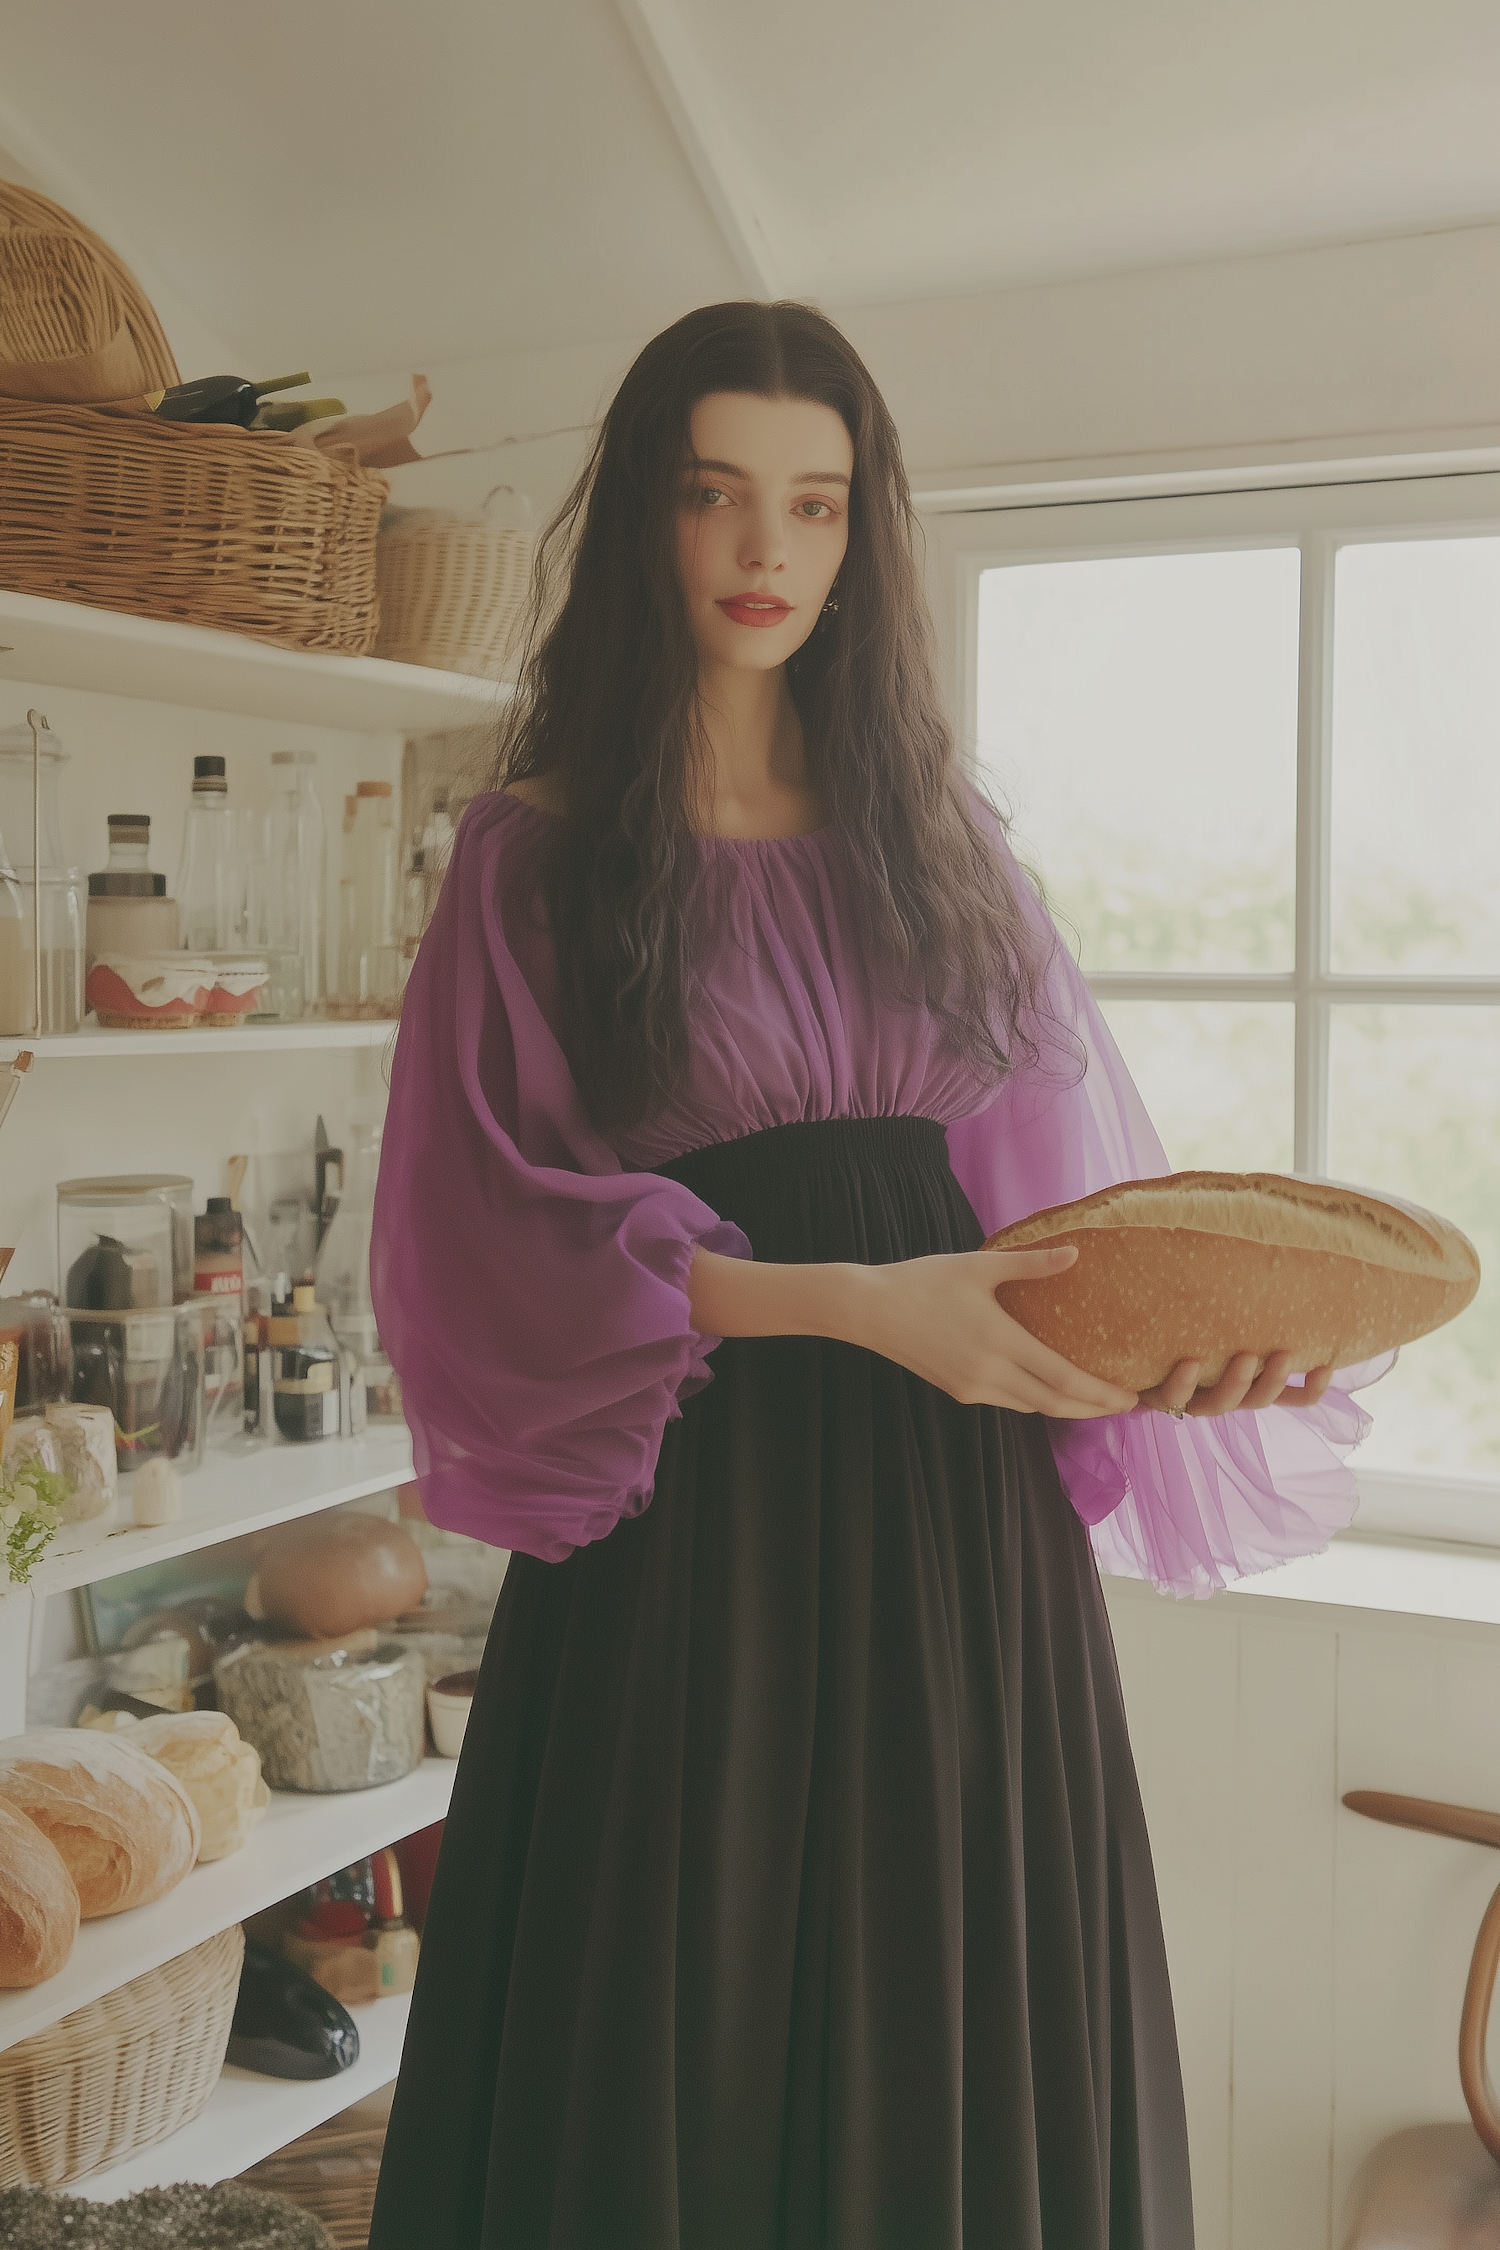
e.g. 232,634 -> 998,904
0,1922 -> 245,2187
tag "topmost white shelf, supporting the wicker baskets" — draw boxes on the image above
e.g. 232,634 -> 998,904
0,590 -> 510,734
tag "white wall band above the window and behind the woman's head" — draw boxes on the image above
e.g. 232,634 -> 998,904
319,225 -> 1500,531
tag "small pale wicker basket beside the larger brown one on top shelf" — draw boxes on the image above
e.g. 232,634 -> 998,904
376,509 -> 531,680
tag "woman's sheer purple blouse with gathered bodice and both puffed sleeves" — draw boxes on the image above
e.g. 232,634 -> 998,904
371,797 -> 1374,1593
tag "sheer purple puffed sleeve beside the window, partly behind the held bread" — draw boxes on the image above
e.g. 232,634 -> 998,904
949,821 -> 1390,1595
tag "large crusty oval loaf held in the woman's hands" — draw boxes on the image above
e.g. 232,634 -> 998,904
985,1172 -> 1480,1391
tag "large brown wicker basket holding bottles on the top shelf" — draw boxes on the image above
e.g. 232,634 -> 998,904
0,398 -> 387,657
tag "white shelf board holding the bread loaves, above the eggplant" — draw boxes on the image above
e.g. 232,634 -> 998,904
0,1757 -> 457,2061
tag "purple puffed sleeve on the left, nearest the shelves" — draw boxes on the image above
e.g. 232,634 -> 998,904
371,797 -> 749,1562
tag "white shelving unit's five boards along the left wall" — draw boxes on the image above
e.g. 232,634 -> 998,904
0,590 -> 470,2198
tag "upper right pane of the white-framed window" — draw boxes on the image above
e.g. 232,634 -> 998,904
1331,540 -> 1500,977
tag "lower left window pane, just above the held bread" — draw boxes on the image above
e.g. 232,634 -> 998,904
1104,999 -> 1293,1172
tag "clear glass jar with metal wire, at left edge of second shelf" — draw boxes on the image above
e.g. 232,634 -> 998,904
0,725 -> 83,1033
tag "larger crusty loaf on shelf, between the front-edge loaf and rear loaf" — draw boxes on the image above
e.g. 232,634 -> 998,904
0,1726 -> 202,1922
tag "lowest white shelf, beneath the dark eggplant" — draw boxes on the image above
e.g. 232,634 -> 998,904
65,1994 -> 412,2203
